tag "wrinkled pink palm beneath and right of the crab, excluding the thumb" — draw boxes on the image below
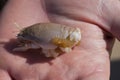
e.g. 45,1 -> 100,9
0,0 -> 115,80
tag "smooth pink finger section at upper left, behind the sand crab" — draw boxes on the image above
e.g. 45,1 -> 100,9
0,0 -> 49,37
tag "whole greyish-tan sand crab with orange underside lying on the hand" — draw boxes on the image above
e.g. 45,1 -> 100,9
14,23 -> 81,57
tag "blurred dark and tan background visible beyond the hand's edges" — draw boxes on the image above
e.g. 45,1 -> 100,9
0,0 -> 120,80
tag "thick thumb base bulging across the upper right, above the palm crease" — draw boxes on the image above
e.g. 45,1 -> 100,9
45,0 -> 120,39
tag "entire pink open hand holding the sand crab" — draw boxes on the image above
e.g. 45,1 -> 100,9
0,0 -> 120,80
